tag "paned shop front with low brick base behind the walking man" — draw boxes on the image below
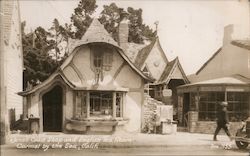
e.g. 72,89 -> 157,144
178,79 -> 250,133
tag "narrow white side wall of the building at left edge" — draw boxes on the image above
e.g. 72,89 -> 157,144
4,1 -> 23,120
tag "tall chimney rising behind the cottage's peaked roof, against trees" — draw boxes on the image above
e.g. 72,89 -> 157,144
118,12 -> 129,51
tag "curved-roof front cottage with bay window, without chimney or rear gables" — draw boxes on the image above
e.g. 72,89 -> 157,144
20,19 -> 152,133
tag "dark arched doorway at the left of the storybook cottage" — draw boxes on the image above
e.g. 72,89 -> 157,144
42,86 -> 63,132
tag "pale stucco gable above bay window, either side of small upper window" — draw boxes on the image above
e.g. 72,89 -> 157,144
63,46 -> 142,88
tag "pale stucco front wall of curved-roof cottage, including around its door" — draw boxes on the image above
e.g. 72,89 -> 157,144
29,46 -> 144,132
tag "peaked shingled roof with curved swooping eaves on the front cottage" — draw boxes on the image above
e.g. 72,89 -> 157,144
19,19 -> 153,96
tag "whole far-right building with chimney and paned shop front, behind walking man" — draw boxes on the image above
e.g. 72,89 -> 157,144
177,25 -> 250,133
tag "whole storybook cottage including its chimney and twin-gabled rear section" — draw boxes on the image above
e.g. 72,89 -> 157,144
20,13 -> 188,133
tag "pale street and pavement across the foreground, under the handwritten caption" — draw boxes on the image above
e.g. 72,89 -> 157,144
1,132 -> 250,156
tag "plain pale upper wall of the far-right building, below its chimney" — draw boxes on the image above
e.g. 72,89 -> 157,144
195,44 -> 250,81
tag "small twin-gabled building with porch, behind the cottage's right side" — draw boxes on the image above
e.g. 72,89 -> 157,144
127,37 -> 189,119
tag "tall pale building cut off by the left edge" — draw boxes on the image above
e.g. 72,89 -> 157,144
0,0 -> 23,143
